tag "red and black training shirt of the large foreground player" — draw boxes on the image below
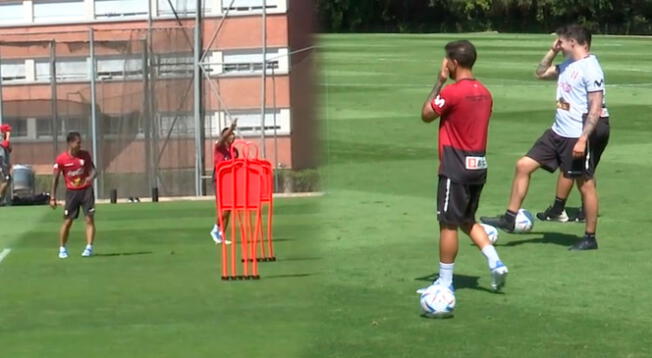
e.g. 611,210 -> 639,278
430,79 -> 493,184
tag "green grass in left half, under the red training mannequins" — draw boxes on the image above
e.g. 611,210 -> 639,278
0,199 -> 321,357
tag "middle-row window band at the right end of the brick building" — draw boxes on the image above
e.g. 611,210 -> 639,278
222,49 -> 288,75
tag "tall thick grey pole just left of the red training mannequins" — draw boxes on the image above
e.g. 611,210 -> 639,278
193,0 -> 204,196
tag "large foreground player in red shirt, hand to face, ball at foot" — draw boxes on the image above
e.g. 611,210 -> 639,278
417,40 -> 507,304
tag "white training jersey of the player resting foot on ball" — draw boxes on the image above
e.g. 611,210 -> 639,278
552,55 -> 609,138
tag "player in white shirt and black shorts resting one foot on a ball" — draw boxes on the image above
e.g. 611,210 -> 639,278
480,25 -> 608,250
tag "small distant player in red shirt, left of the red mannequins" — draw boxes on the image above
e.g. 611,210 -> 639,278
50,132 -> 96,259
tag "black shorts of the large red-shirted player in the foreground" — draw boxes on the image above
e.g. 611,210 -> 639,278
437,175 -> 484,226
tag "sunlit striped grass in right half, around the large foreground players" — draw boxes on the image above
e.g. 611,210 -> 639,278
321,34 -> 652,357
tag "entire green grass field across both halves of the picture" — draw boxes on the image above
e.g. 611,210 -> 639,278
0,34 -> 652,358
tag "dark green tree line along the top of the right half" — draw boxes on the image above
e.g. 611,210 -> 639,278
316,0 -> 652,35
